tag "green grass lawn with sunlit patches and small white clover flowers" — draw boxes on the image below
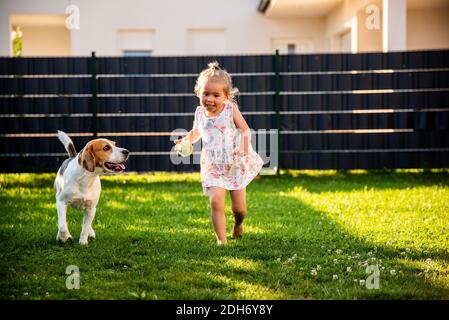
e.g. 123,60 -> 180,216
0,170 -> 449,300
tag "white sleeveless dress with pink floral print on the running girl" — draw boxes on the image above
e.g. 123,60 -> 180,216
193,102 -> 263,195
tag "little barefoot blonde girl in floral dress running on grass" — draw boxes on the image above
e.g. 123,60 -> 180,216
174,61 -> 263,245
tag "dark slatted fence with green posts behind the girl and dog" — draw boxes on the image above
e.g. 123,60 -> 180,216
0,50 -> 449,172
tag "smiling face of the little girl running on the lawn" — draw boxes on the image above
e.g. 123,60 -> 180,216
199,78 -> 228,115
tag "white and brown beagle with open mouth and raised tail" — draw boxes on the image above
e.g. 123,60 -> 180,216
54,131 -> 129,245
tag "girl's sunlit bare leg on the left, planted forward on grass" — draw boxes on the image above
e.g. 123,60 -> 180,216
208,187 -> 227,245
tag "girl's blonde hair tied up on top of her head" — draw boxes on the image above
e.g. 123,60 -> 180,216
194,61 -> 239,102
